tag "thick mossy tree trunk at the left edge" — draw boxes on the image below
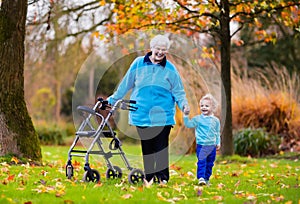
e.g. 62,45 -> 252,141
0,0 -> 42,161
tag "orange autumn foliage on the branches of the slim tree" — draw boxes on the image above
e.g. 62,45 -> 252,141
100,0 -> 300,45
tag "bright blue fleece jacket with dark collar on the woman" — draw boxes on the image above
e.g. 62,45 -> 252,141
107,52 -> 188,127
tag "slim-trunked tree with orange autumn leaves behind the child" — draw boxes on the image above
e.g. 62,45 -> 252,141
100,0 -> 300,155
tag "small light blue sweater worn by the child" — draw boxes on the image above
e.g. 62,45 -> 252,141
183,114 -> 220,145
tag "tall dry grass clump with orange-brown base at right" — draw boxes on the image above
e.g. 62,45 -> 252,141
232,68 -> 300,151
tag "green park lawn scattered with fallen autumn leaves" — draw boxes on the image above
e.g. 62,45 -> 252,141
0,145 -> 300,204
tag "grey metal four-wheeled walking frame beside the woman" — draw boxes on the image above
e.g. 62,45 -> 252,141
66,98 -> 144,184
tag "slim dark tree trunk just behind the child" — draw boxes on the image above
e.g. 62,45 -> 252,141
220,0 -> 233,155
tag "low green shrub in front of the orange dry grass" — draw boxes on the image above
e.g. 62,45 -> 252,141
234,128 -> 280,157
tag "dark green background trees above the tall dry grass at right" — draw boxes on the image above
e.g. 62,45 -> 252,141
240,18 -> 300,73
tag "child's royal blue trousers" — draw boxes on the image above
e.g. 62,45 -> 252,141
196,144 -> 216,181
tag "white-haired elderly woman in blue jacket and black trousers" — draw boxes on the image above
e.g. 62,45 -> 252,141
107,35 -> 189,184
